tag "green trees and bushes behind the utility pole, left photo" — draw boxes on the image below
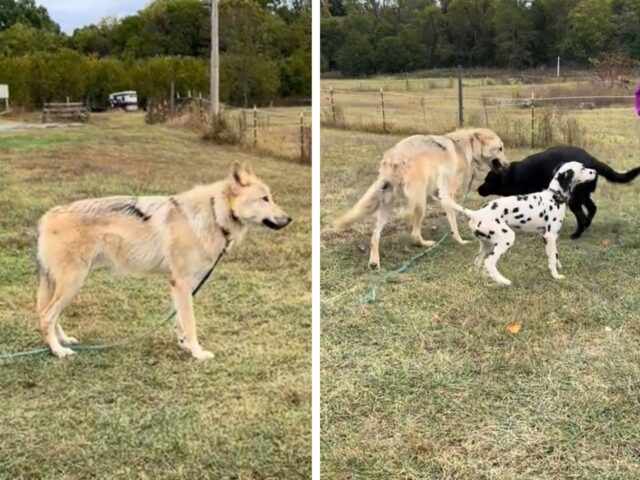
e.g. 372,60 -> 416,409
0,0 -> 311,106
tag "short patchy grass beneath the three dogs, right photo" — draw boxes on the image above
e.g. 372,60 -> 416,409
321,105 -> 640,474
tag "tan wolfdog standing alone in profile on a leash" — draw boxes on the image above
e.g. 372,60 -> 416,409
37,163 -> 291,359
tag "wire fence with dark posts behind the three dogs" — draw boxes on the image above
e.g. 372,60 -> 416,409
321,79 -> 635,148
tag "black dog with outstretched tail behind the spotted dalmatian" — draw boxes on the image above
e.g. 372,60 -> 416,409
478,147 -> 640,238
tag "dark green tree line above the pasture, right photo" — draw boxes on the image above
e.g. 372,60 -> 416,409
321,0 -> 640,76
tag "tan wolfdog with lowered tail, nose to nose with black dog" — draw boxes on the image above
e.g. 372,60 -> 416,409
335,128 -> 507,268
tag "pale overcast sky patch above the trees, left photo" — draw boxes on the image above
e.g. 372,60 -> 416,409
36,0 -> 150,34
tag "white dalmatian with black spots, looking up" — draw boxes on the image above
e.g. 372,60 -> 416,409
438,162 -> 597,285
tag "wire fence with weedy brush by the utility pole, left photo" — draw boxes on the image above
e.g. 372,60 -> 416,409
146,95 -> 311,164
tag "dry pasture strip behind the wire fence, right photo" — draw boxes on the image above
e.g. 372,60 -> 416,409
321,78 -> 634,147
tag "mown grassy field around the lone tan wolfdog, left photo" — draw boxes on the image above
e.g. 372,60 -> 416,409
0,114 -> 311,480
